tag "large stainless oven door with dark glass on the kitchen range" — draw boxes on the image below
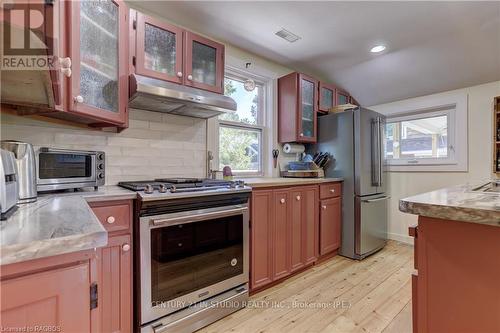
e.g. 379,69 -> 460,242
140,204 -> 249,325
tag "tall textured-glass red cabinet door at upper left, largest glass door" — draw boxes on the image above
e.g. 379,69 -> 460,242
69,0 -> 128,124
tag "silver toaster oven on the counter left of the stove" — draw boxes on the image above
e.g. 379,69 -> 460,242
36,147 -> 105,191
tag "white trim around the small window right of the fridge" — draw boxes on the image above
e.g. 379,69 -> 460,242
370,91 -> 468,172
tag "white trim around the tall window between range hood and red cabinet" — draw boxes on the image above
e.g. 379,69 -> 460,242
213,65 -> 272,178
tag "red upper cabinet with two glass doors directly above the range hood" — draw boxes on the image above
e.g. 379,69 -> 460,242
130,10 -> 224,94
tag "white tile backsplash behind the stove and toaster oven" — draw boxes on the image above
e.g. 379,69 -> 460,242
0,110 -> 207,185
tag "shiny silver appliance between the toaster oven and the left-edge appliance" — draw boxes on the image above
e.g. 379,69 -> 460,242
0,140 -> 37,204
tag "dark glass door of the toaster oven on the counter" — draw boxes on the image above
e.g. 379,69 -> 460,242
36,150 -> 96,189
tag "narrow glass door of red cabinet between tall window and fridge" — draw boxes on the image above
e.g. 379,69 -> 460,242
299,74 -> 318,142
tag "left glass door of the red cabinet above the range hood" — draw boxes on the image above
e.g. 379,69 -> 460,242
134,13 -> 184,83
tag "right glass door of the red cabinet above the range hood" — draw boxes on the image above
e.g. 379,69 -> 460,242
184,32 -> 224,94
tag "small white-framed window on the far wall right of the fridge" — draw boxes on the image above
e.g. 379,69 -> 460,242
375,92 -> 467,171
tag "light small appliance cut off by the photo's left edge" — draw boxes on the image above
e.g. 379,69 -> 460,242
0,149 -> 18,220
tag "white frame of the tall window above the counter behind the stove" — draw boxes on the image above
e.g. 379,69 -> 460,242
213,66 -> 270,177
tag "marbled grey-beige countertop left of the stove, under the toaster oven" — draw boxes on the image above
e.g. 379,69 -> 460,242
0,186 -> 137,265
